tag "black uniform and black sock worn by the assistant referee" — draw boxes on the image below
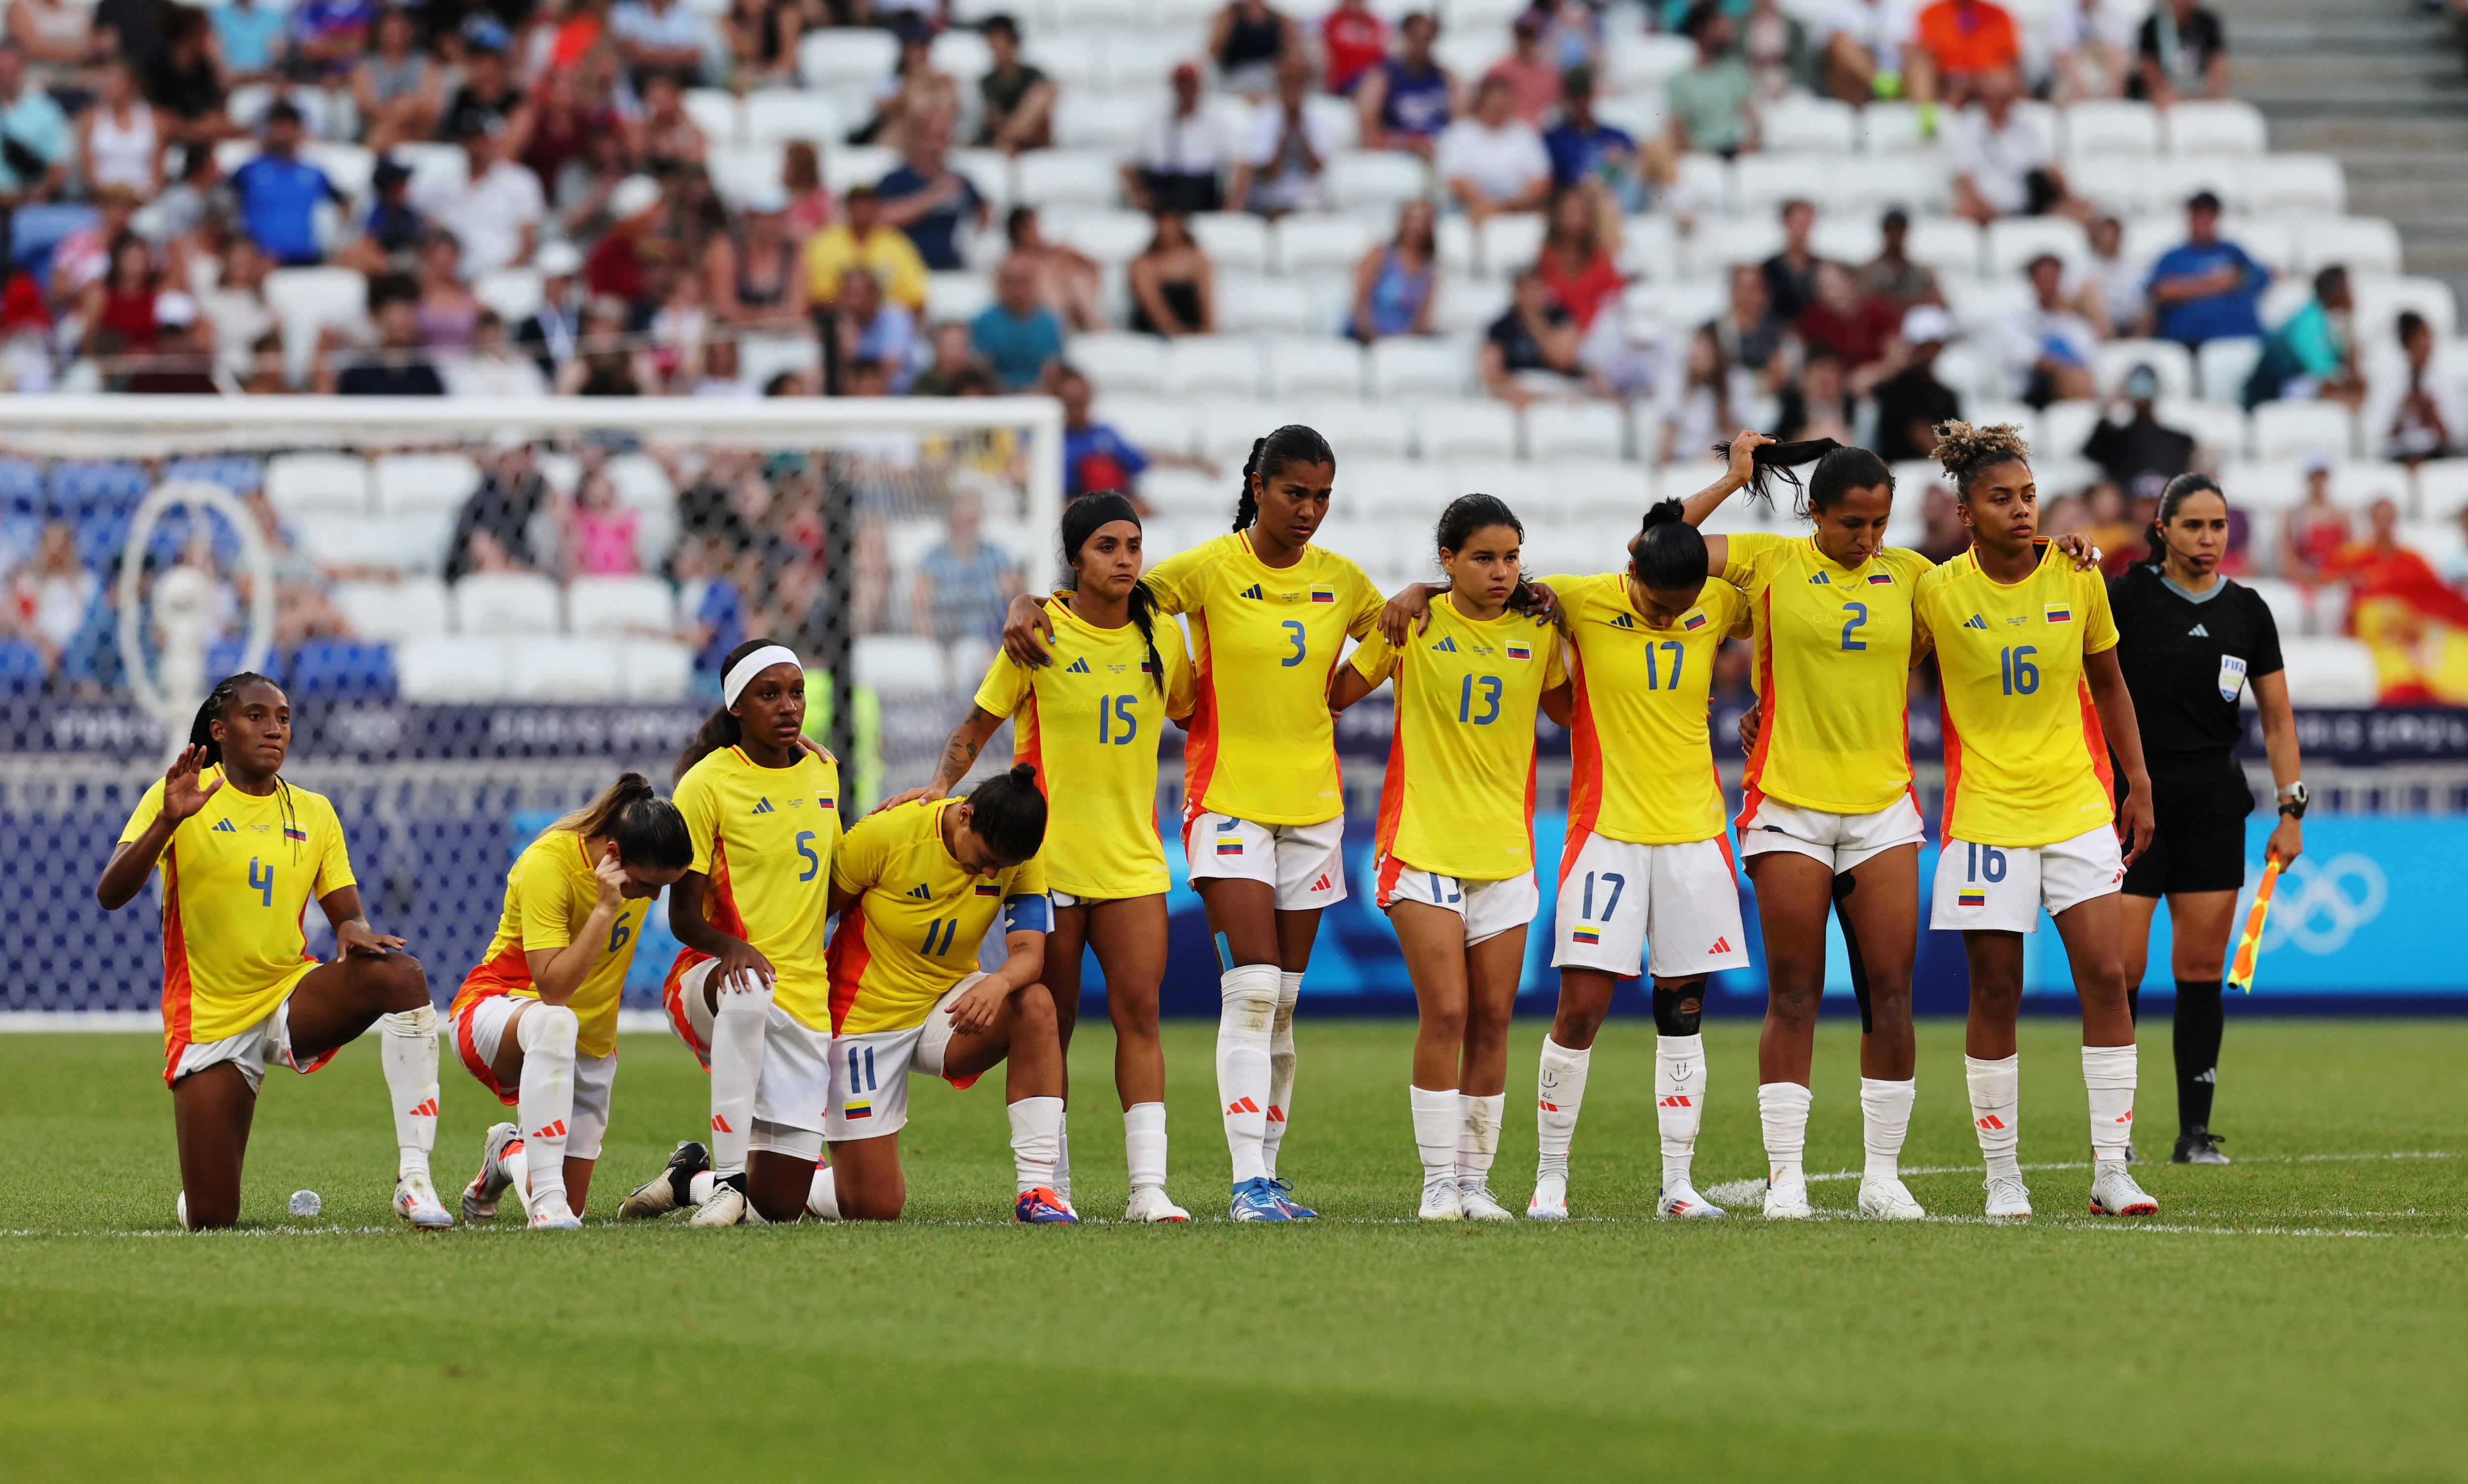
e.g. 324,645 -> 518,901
2108,563 -> 2285,1136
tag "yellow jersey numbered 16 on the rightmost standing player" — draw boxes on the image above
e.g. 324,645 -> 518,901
1918,541 -> 2118,847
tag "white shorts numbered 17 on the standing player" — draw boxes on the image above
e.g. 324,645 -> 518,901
1550,835 -> 1747,980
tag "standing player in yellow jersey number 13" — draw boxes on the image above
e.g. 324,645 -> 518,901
1328,494 -> 1567,1222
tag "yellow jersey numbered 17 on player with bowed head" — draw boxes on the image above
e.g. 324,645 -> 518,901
1545,573 -> 1747,859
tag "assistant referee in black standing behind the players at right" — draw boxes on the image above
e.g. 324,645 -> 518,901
2108,474 -> 2305,1166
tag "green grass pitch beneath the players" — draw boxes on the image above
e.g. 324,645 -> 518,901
0,1020 -> 2468,1484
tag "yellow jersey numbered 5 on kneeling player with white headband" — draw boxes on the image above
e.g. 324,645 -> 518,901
669,748 -> 839,1029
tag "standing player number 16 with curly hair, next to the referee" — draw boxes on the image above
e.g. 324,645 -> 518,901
1915,422 -> 2160,1220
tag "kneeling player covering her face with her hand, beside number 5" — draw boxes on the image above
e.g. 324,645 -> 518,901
452,773 -> 694,1230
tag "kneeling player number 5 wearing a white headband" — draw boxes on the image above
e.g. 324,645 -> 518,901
617,640 -> 839,1227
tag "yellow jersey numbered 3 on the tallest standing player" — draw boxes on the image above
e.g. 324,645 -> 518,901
1143,531 -> 1382,825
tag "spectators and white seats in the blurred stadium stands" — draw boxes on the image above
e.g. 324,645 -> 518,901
0,0 -> 2468,706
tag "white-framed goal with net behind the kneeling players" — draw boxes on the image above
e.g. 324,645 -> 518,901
0,398 -> 1061,1015
